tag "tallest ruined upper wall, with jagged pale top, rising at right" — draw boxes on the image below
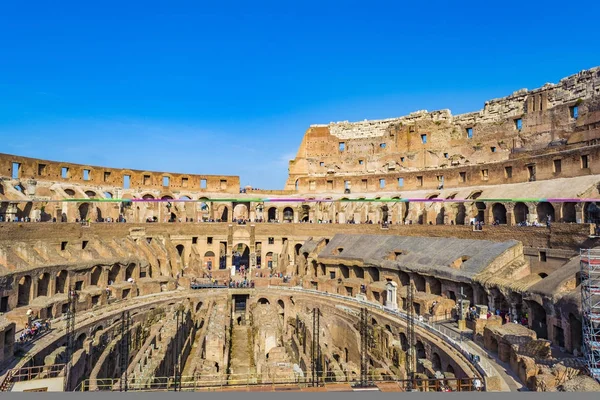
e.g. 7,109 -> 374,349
286,67 -> 600,189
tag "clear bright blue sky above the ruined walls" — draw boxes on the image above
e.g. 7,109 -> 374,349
0,0 -> 600,189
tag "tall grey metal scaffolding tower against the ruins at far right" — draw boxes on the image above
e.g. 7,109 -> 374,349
580,249 -> 600,382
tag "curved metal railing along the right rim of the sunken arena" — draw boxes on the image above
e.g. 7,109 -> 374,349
269,285 -> 499,377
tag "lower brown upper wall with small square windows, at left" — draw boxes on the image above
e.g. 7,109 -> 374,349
0,154 -> 240,193
